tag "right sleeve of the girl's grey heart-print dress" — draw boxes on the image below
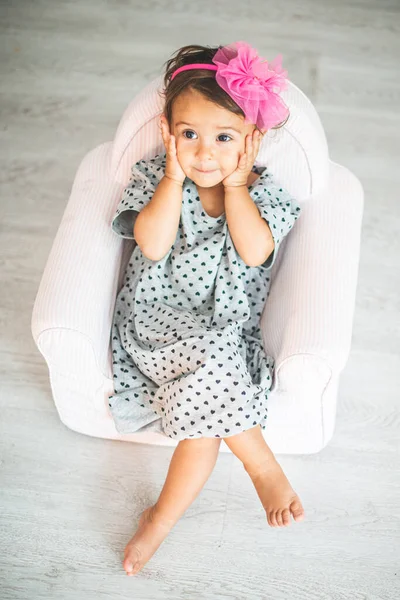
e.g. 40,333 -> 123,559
250,175 -> 301,269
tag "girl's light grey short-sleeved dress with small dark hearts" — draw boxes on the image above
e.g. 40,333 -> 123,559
109,154 -> 300,440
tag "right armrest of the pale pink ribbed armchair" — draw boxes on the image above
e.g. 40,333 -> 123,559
261,161 -> 364,382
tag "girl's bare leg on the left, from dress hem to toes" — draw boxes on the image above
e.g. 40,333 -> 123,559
123,438 -> 222,575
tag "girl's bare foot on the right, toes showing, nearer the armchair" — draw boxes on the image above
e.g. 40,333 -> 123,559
246,459 -> 304,527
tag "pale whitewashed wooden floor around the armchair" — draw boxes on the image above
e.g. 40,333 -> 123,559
0,0 -> 400,600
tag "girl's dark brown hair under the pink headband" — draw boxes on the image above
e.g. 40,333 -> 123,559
161,45 -> 290,129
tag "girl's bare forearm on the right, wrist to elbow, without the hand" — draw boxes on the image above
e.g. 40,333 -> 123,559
225,185 -> 275,267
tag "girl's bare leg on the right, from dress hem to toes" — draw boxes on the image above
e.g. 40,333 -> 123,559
223,425 -> 304,527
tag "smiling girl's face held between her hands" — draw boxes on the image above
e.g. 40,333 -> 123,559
171,89 -> 255,188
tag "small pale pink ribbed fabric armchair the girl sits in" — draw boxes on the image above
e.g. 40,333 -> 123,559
32,78 -> 364,454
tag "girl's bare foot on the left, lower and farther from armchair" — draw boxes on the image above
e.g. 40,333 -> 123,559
122,506 -> 175,575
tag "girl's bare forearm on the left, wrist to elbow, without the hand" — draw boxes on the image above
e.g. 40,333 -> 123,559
133,176 -> 183,260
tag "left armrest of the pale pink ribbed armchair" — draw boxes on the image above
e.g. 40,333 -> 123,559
31,142 -> 123,377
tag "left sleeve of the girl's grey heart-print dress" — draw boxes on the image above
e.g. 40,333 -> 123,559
111,155 -> 165,240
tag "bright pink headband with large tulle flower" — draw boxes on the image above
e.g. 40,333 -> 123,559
171,42 -> 289,130
